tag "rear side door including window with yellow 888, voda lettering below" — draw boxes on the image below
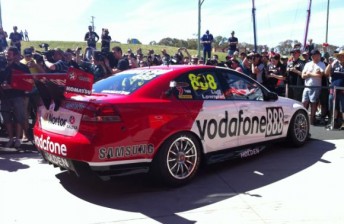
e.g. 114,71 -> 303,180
176,69 -> 238,153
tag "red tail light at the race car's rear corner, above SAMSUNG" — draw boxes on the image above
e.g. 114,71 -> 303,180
81,104 -> 121,122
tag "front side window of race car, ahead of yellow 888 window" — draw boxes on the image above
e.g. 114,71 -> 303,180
221,71 -> 264,101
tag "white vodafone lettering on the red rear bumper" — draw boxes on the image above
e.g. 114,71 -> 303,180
34,135 -> 67,156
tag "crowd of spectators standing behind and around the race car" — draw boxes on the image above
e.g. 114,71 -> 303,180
0,26 -> 344,148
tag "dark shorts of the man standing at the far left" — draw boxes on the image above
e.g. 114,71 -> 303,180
1,96 -> 26,125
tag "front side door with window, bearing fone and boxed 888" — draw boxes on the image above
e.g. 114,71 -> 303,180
216,70 -> 284,146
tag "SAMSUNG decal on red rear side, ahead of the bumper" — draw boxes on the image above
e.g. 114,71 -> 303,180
99,144 -> 154,159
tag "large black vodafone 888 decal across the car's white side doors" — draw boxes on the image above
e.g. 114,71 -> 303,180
196,107 -> 284,140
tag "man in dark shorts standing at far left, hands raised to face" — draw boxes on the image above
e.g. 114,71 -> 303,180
0,46 -> 30,149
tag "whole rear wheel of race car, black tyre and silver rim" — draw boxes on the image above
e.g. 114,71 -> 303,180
153,133 -> 201,187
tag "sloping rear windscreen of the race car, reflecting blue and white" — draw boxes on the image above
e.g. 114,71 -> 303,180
92,69 -> 169,95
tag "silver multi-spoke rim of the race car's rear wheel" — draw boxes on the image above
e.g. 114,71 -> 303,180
167,137 -> 198,179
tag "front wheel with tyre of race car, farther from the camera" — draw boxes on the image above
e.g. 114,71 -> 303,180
288,110 -> 309,147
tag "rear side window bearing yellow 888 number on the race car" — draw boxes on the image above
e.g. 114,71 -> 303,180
175,70 -> 225,100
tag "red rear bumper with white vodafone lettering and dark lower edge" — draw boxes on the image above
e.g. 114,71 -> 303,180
34,129 -> 151,179
